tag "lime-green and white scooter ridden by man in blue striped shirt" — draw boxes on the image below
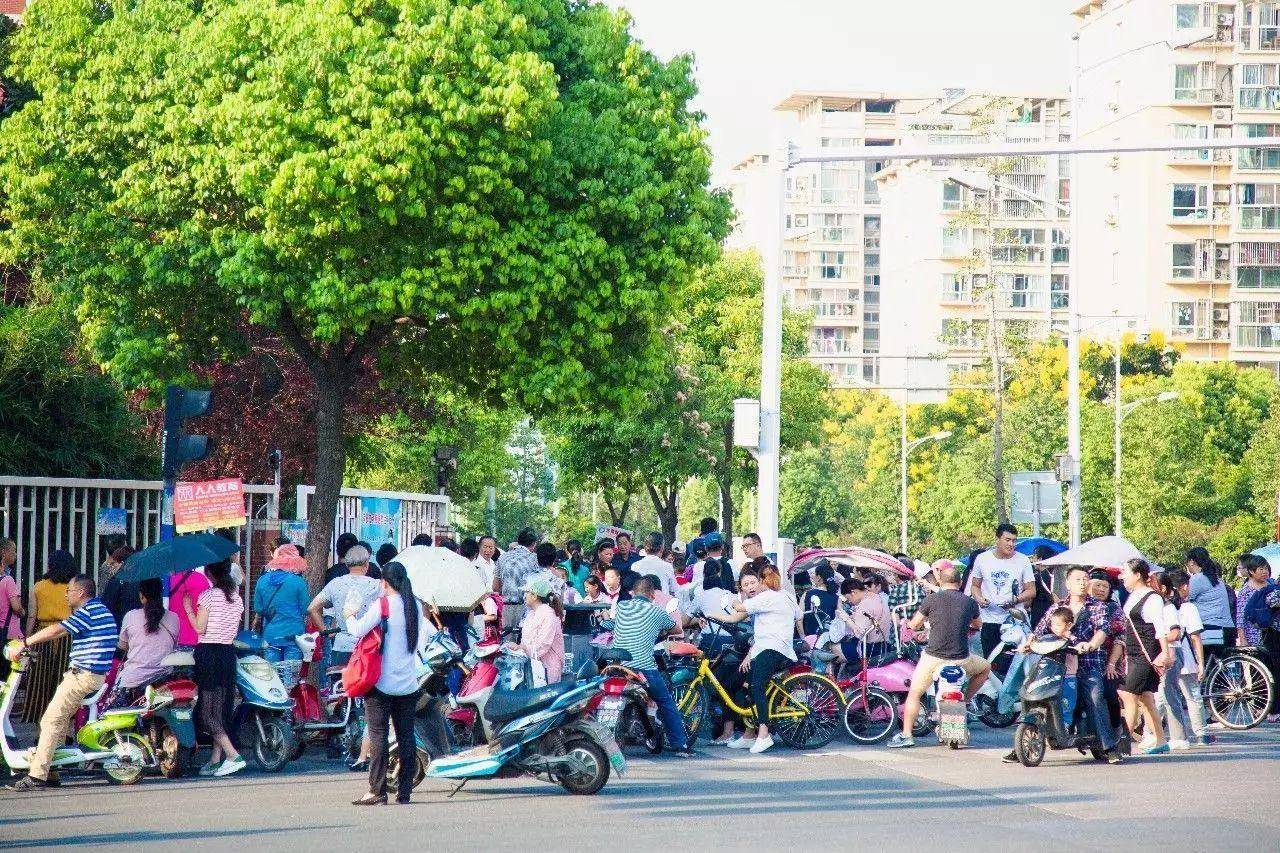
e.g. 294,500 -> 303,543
0,640 -> 156,785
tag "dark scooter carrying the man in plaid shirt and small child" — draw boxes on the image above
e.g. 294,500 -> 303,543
1014,638 -> 1107,767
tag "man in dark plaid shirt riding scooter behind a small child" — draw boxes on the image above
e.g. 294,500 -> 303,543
1001,566 -> 1120,765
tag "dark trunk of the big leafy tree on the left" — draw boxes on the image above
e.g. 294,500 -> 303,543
307,361 -> 348,591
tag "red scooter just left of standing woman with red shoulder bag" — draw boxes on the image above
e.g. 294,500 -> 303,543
273,628 -> 364,765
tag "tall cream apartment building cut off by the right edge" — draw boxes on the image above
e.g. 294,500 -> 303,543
1074,0 -> 1280,373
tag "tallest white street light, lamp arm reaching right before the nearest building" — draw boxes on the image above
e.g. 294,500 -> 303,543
1066,27 -> 1215,548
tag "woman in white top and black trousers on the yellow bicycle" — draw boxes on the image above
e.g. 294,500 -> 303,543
708,566 -> 800,753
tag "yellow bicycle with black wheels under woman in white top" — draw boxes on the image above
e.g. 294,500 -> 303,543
676,614 -> 844,749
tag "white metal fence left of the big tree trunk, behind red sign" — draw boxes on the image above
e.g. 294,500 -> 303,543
0,476 -> 278,592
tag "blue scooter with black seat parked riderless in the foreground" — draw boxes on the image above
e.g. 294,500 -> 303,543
426,660 -> 627,797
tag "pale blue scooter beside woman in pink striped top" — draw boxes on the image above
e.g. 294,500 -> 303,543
232,631 -> 293,772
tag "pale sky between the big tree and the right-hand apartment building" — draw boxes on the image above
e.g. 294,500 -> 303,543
605,0 -> 1074,184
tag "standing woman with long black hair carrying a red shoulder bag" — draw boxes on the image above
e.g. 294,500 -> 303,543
343,561 -> 422,806
